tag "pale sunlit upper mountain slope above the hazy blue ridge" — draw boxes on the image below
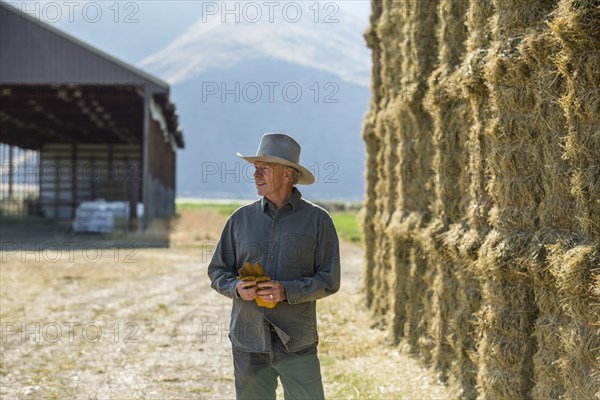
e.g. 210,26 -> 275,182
140,2 -> 370,87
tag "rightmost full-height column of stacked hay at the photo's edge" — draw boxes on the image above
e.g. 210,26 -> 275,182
550,0 -> 600,398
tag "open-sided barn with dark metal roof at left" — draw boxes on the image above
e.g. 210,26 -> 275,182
0,2 -> 184,226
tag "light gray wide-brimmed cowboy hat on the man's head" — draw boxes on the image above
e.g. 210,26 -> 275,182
237,133 -> 315,185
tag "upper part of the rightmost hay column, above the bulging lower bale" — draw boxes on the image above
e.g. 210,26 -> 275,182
550,0 -> 600,240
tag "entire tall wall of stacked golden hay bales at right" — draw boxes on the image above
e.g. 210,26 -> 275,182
363,0 -> 600,399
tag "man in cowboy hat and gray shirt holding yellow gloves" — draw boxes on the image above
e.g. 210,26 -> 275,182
208,133 -> 340,399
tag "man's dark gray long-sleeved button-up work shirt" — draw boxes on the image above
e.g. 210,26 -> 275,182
208,187 -> 340,353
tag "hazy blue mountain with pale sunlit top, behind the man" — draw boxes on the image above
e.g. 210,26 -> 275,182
138,2 -> 370,200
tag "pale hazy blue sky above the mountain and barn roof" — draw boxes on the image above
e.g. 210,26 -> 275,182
9,0 -> 371,64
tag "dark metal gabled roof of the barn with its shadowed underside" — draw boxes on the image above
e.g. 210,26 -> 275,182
0,1 -> 184,148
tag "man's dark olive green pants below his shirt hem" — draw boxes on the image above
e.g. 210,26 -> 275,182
233,331 -> 325,400
